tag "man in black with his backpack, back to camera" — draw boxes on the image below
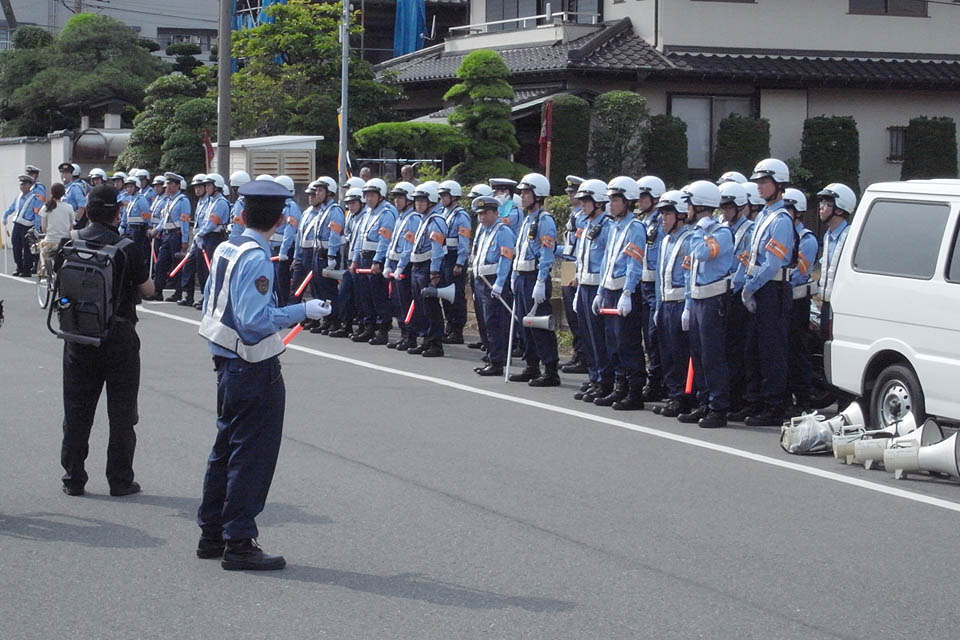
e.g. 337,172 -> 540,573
56,185 -> 153,496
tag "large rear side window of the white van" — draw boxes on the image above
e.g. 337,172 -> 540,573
853,200 -> 950,280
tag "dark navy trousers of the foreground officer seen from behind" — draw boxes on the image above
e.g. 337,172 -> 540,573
197,356 -> 286,540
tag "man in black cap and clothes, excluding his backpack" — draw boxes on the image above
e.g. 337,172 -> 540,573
60,185 -> 154,496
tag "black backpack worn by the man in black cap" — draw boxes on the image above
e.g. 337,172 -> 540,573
47,238 -> 133,347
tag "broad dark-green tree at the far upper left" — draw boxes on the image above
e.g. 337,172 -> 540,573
0,13 -> 168,135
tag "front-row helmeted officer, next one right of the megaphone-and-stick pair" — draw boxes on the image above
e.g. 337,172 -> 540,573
573,179 -> 614,402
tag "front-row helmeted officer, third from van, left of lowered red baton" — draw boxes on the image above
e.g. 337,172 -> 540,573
653,191 -> 691,418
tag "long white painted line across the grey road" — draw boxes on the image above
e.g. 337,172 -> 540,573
0,274 -> 960,513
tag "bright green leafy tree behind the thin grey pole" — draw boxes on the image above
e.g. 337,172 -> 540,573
225,0 -> 403,158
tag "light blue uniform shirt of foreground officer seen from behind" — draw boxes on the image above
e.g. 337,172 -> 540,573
203,229 -> 307,358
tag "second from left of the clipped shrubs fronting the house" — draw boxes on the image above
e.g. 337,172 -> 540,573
590,91 -> 650,177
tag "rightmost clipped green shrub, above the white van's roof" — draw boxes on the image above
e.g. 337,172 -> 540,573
900,116 -> 957,180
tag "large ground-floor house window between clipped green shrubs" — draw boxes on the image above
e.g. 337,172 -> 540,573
669,95 -> 755,173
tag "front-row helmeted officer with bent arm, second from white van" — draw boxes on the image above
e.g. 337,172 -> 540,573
677,180 -> 739,429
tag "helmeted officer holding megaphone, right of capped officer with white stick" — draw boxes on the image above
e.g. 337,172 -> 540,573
510,173 -> 560,387
